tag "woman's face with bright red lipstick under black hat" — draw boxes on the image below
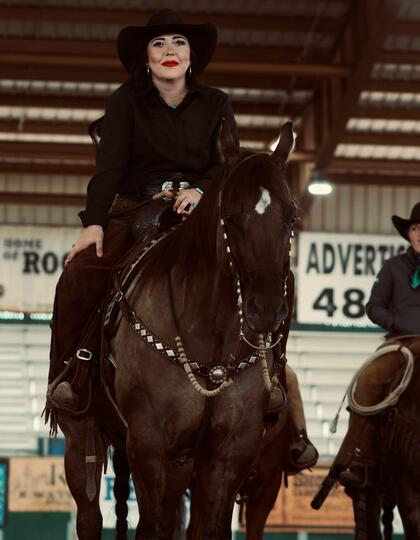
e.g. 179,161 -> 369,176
147,34 -> 191,80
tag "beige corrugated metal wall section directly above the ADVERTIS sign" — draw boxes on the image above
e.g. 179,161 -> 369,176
304,185 -> 420,234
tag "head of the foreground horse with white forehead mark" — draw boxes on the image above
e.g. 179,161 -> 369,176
220,122 -> 297,333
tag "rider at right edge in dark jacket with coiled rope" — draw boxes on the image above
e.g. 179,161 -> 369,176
312,203 -> 420,509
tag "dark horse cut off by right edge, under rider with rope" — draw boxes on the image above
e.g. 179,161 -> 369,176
353,336 -> 420,540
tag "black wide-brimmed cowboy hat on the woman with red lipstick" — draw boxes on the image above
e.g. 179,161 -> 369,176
117,9 -> 217,73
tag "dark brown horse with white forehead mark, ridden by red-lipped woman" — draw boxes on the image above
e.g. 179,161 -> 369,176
113,120 -> 296,540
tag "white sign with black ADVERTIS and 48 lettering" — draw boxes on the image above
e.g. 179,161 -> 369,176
296,232 -> 408,326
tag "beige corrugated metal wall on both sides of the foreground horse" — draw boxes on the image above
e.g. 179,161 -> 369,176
0,174 -> 420,234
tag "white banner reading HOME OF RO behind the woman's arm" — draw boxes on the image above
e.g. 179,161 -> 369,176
0,225 -> 80,312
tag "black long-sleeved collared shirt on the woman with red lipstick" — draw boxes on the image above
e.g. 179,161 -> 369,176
79,81 -> 239,227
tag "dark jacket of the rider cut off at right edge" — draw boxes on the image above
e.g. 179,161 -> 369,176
366,246 -> 420,337
